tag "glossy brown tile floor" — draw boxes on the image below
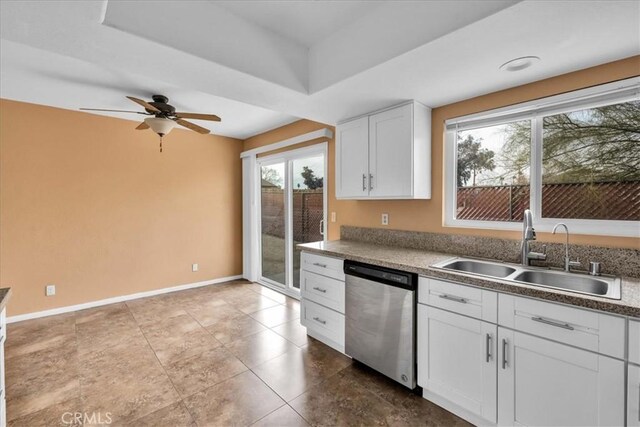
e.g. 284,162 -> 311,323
6,281 -> 466,427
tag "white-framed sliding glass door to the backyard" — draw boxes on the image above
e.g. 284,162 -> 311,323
257,144 -> 326,294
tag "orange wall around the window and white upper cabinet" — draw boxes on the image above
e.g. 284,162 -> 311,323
244,56 -> 640,248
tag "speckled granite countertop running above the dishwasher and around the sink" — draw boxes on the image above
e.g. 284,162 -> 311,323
298,240 -> 640,317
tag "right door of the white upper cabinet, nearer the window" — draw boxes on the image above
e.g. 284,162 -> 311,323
369,104 -> 412,198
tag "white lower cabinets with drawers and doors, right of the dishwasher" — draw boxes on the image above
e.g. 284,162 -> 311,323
417,278 -> 628,427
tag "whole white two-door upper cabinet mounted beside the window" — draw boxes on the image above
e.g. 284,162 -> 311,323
336,102 -> 431,199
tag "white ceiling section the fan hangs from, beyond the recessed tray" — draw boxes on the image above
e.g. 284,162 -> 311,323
0,40 -> 298,139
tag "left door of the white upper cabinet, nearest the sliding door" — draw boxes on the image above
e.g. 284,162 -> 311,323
336,117 -> 369,199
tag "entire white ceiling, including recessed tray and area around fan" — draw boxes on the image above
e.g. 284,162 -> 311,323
0,0 -> 640,138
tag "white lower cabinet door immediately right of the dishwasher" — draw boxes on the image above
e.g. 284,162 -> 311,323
418,304 -> 497,423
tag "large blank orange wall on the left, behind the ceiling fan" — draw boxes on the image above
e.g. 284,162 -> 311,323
0,100 -> 242,315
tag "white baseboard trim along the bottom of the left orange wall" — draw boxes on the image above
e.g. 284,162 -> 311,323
7,274 -> 242,323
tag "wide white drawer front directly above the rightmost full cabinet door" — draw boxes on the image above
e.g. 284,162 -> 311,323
498,294 -> 625,359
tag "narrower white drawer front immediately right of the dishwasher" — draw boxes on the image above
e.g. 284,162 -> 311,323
418,277 -> 498,323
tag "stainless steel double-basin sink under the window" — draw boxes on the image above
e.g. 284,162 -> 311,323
432,258 -> 620,299
